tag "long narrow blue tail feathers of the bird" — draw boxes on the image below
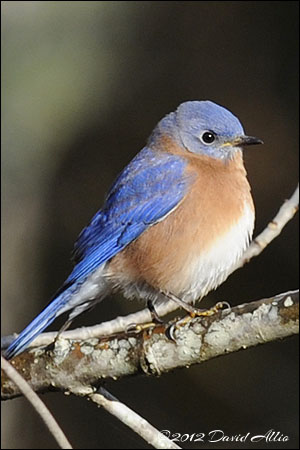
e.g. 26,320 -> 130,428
4,289 -> 71,359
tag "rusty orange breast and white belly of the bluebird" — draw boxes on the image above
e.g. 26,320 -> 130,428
110,150 -> 254,302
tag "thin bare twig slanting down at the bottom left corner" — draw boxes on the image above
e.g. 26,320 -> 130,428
1,356 -> 73,449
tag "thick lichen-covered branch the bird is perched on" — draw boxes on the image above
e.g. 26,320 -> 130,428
1,291 -> 299,399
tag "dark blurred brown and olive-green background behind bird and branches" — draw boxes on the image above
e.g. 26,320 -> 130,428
2,1 -> 299,449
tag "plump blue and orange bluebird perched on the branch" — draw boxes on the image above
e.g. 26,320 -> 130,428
5,101 -> 262,358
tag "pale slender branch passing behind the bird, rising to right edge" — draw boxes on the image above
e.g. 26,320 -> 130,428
1,185 -> 299,349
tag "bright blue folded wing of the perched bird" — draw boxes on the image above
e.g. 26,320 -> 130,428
67,147 -> 190,282
